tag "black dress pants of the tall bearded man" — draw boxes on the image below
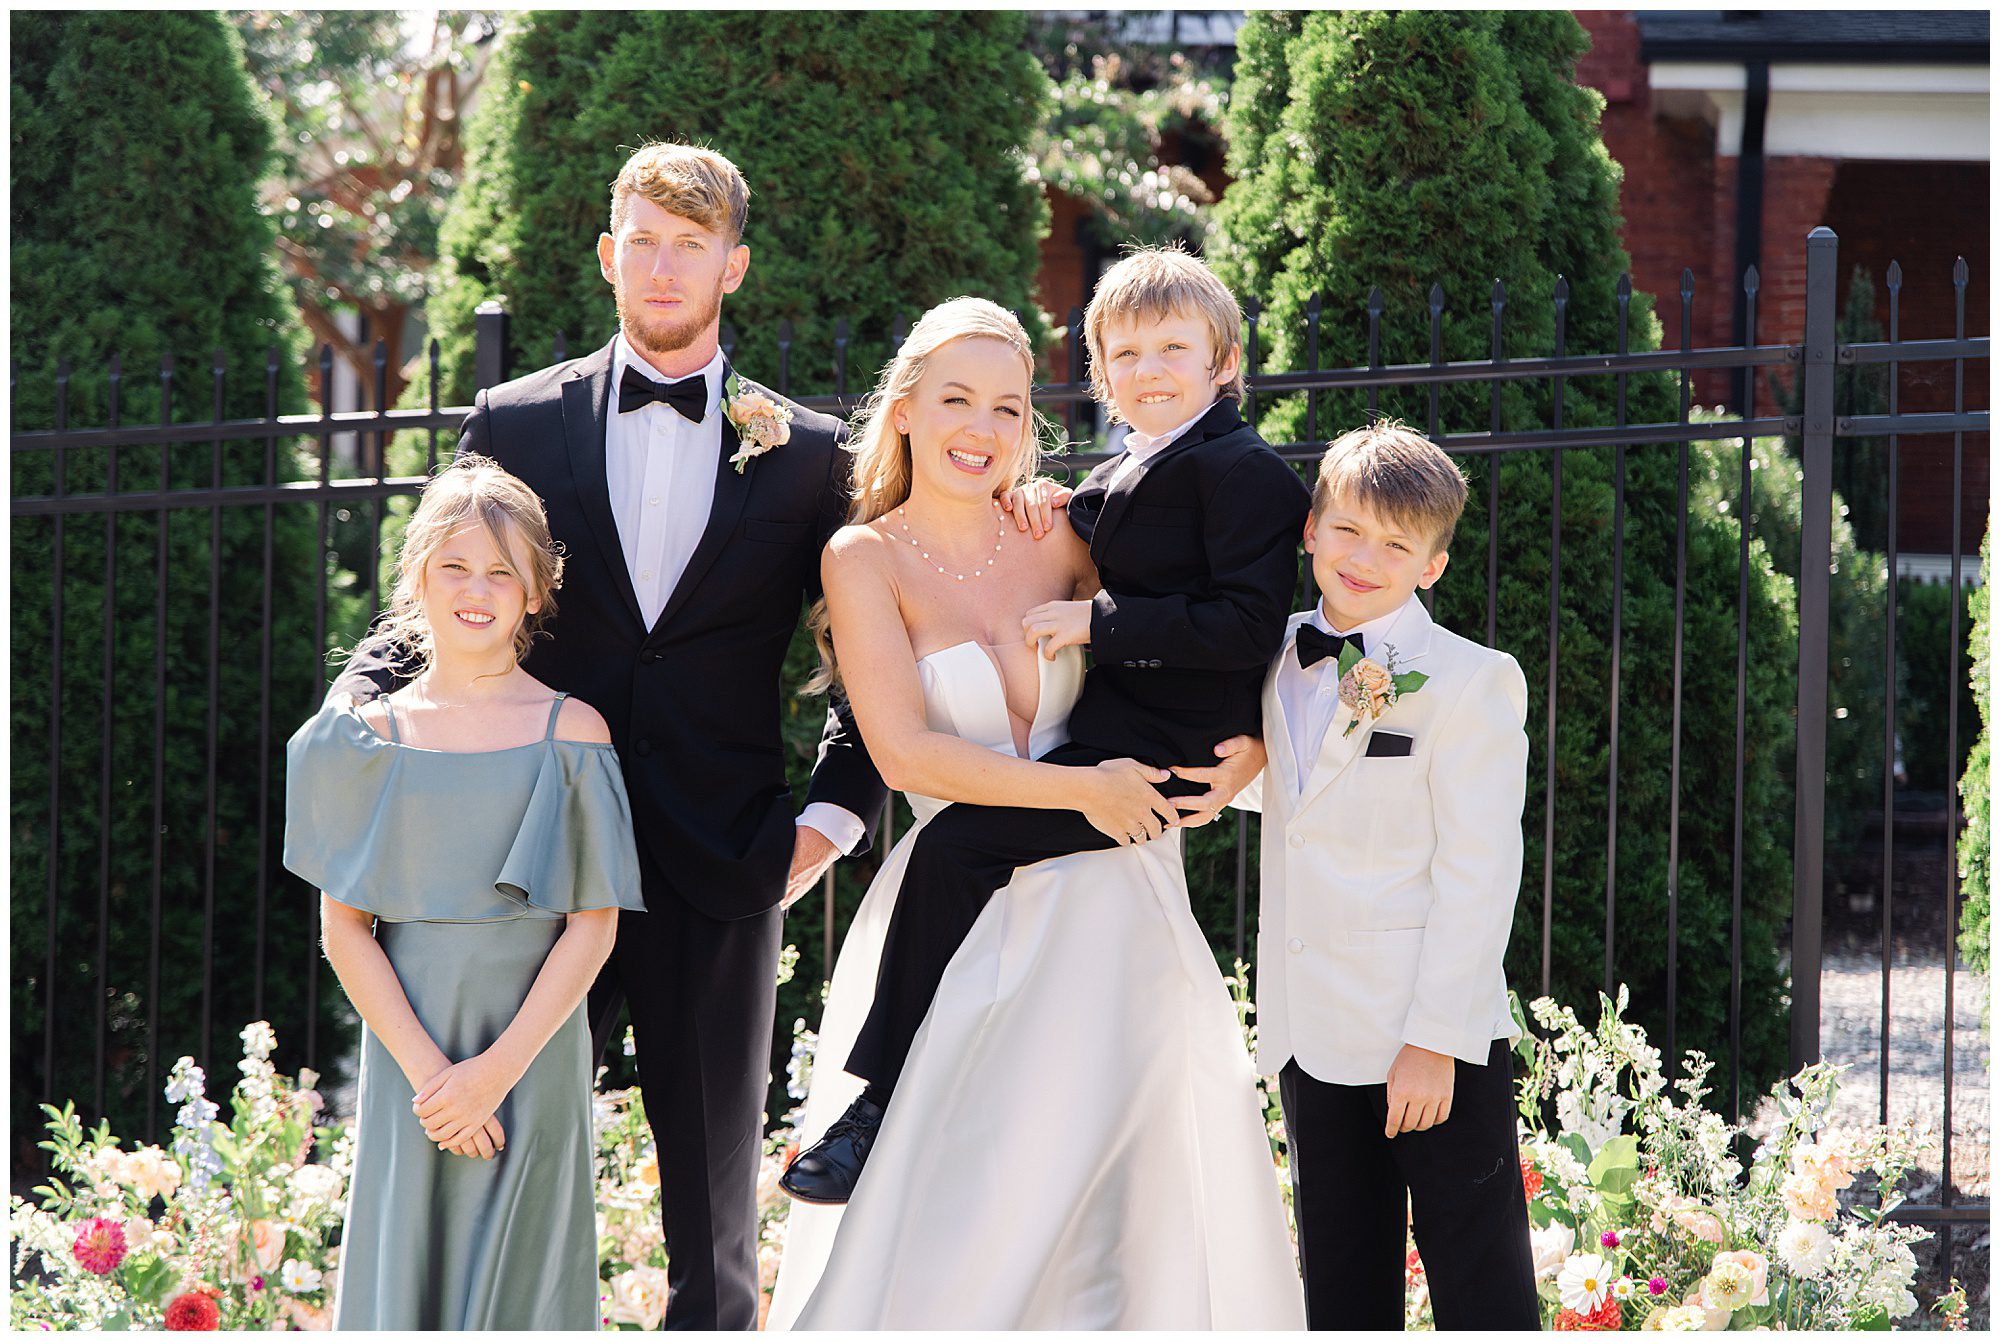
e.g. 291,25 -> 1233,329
590,881 -> 784,1331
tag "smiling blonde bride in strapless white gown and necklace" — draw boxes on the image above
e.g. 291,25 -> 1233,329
770,298 -> 1304,1329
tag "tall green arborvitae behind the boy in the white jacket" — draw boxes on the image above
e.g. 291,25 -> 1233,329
1214,12 -> 1796,1083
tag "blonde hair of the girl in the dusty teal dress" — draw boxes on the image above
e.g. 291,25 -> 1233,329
354,456 -> 562,677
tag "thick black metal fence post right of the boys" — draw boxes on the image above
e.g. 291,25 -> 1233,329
1792,228 -> 1840,1071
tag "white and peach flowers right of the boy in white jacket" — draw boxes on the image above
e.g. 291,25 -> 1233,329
1520,987 -> 1930,1331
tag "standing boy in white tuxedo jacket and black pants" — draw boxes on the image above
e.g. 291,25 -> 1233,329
1238,424 -> 1540,1329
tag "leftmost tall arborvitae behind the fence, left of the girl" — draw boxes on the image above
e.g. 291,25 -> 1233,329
10,12 -> 338,1149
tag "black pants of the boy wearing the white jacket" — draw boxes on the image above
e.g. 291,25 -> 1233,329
1278,1039 -> 1542,1331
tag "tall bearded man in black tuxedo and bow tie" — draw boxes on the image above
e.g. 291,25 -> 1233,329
334,144 -> 884,1331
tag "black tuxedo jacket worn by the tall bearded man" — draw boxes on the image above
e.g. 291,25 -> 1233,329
334,344 -> 884,919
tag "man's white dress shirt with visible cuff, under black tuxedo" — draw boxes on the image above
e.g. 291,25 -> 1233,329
604,330 -> 868,853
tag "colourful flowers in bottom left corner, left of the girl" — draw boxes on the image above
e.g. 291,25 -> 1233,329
8,1021 -> 354,1331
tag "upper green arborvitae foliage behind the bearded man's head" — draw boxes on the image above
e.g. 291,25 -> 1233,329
416,10 -> 1048,414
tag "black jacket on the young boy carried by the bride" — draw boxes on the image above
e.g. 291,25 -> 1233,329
1070,400 -> 1312,769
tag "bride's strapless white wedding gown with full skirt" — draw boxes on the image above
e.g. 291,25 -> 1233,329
768,642 -> 1306,1329
